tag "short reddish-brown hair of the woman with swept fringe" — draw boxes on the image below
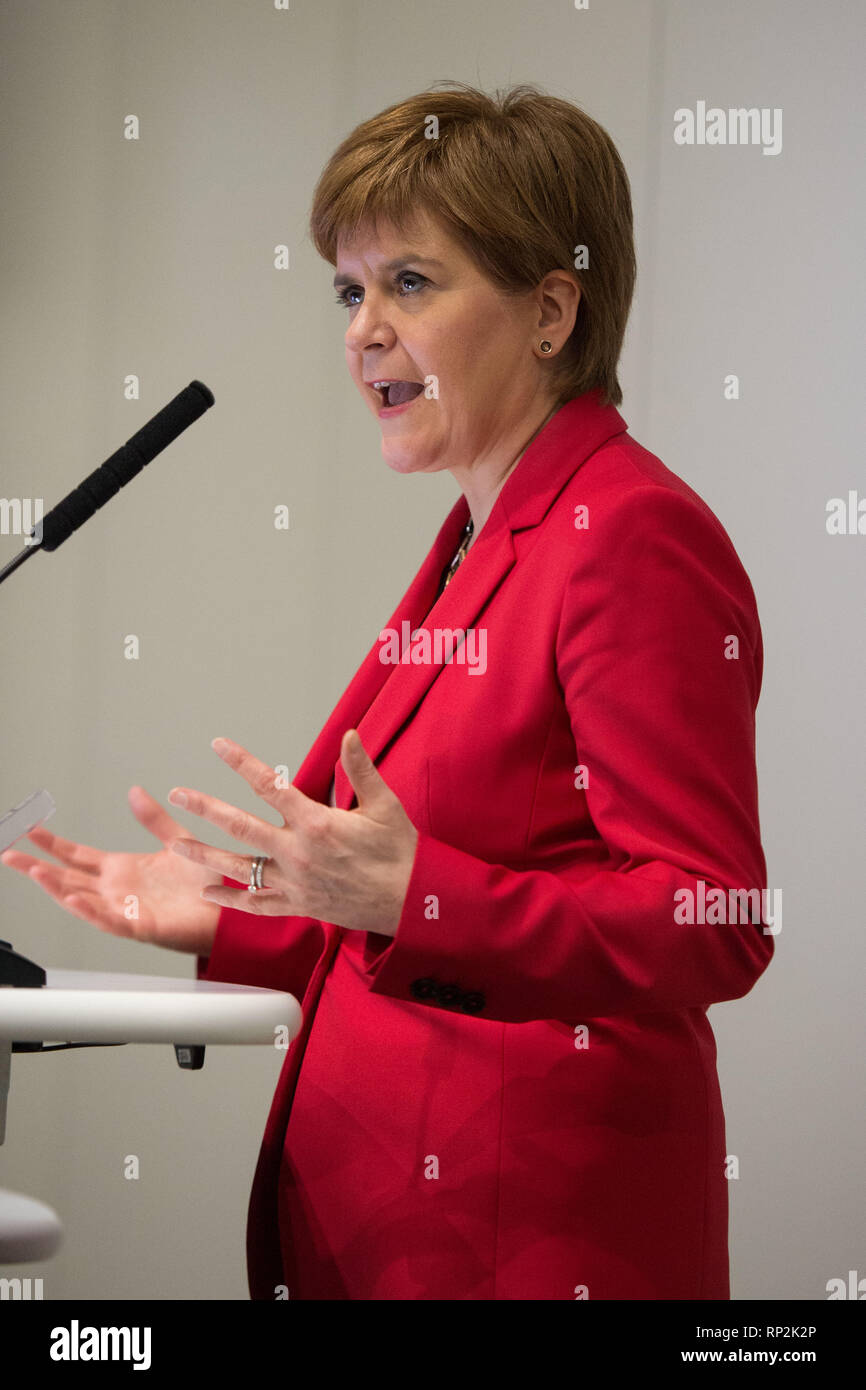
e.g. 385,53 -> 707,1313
310,82 -> 637,406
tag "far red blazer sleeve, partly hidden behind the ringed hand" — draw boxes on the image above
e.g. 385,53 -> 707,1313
196,874 -> 324,999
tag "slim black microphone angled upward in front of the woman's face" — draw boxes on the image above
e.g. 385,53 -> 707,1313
0,381 -> 214,582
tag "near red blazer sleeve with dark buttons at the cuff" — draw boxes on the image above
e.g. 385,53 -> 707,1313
355,485 -> 776,1023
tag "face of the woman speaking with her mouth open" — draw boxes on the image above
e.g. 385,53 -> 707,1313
334,214 -> 550,475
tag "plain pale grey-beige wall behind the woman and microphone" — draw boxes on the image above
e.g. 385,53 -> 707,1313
0,0 -> 866,1300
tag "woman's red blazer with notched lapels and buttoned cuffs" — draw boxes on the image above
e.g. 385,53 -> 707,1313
199,392 -> 773,1300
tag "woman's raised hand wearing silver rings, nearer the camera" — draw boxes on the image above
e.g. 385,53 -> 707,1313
168,730 -> 418,937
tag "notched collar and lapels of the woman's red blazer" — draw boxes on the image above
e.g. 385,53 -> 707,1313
295,391 -> 628,810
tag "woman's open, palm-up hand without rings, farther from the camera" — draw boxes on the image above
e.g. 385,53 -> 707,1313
0,787 -> 221,955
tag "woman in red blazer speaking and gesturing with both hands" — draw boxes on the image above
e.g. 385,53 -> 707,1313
4,85 -> 771,1300
